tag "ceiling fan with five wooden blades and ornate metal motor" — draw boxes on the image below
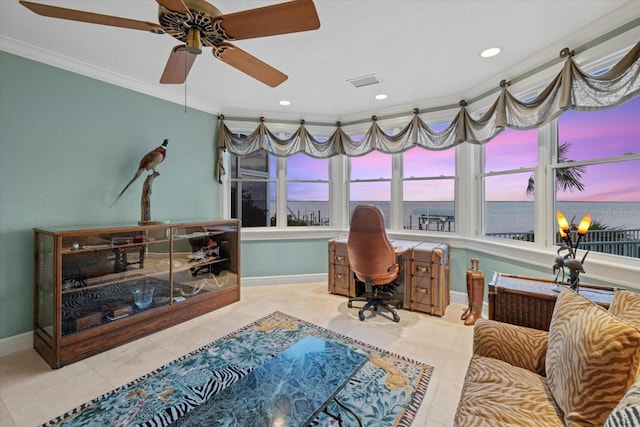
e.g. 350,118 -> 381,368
20,0 -> 320,87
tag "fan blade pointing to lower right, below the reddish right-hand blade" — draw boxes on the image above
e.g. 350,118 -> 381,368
212,43 -> 289,87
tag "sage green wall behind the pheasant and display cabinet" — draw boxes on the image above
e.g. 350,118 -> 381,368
0,52 -> 220,338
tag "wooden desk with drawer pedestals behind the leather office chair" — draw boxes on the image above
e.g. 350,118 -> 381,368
327,236 -> 450,316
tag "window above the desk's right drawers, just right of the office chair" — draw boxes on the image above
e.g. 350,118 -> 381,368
402,148 -> 456,231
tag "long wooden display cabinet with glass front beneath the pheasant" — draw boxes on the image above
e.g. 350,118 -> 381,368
34,220 -> 240,368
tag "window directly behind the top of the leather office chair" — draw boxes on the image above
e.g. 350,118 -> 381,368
349,151 -> 393,228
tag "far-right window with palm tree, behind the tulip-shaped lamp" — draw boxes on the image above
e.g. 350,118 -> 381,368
552,97 -> 640,258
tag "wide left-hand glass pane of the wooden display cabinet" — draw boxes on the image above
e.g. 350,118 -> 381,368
60,228 -> 170,336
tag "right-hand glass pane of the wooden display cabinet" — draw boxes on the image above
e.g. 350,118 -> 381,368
173,223 -> 239,302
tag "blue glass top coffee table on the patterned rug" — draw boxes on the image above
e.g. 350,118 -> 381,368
174,336 -> 367,427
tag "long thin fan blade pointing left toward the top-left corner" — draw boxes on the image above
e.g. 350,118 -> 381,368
20,0 -> 164,33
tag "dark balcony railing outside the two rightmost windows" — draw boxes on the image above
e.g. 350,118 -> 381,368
486,229 -> 640,258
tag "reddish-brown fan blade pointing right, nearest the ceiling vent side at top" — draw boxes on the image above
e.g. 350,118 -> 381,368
220,0 -> 320,40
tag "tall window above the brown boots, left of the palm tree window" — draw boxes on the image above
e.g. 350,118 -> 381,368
481,129 -> 538,242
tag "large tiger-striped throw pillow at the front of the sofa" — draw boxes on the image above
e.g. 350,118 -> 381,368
546,287 -> 640,426
